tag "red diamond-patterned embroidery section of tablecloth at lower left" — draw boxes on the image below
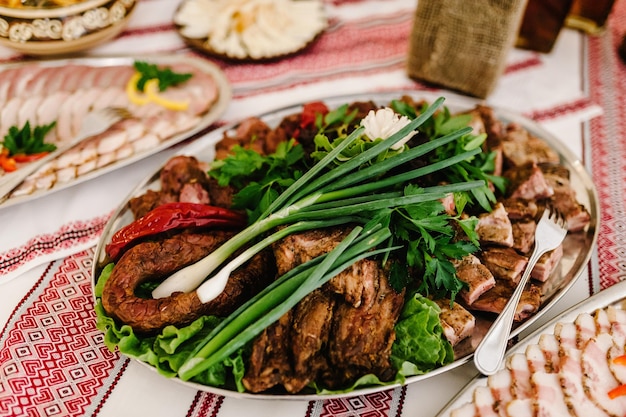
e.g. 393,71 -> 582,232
0,251 -> 119,416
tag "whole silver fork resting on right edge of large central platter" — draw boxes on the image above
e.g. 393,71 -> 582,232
474,207 -> 567,375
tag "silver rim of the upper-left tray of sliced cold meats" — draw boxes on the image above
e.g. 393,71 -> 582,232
0,55 -> 232,209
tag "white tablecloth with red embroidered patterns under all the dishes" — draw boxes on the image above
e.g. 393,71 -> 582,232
0,0 -> 626,417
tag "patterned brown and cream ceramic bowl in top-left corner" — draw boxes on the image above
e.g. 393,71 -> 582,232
0,0 -> 137,55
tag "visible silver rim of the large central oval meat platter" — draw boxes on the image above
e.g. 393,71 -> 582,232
92,91 -> 599,400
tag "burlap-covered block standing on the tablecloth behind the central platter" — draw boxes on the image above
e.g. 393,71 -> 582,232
407,0 -> 526,98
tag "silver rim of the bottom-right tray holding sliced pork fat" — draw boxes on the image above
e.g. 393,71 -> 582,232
437,281 -> 626,417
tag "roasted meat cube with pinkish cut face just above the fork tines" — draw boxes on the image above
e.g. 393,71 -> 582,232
502,162 -> 554,200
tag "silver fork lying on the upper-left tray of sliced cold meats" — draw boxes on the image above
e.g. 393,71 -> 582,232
0,107 -> 131,202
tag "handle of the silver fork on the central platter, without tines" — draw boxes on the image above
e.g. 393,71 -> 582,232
474,247 -> 547,375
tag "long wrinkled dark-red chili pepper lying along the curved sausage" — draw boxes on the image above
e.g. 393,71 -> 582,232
105,202 -> 247,260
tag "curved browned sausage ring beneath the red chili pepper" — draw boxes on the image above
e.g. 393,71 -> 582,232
102,231 -> 274,333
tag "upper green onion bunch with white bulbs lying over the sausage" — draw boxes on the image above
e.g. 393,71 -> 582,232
152,98 -> 485,302
